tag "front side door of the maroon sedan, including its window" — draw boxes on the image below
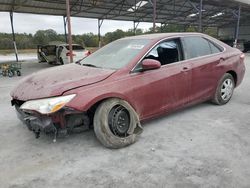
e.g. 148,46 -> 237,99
131,38 -> 191,119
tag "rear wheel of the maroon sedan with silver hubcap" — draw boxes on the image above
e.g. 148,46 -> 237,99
212,73 -> 235,105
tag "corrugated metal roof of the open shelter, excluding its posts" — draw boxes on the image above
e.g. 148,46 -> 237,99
0,0 -> 250,27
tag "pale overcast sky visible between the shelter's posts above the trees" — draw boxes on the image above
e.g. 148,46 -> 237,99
0,12 -> 156,35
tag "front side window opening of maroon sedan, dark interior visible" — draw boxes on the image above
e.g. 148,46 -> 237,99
144,39 -> 182,65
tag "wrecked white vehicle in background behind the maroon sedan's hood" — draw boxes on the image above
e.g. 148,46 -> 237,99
37,44 -> 90,65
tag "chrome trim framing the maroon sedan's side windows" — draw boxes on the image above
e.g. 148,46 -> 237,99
129,34 -> 226,74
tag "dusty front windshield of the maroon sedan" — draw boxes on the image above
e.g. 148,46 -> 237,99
80,39 -> 150,69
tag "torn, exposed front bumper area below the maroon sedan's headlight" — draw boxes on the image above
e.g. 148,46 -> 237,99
11,99 -> 90,142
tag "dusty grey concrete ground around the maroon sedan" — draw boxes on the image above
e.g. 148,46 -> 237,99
0,55 -> 250,188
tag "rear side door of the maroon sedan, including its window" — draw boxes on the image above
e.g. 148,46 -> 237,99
182,36 -> 222,102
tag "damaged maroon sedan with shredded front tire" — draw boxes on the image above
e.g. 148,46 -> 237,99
11,33 -> 245,148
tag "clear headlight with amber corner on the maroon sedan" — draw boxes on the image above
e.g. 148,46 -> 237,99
20,94 -> 76,114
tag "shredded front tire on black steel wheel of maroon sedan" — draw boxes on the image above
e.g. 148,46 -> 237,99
94,98 -> 142,149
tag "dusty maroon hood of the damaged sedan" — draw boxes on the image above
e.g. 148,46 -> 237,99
11,64 -> 115,101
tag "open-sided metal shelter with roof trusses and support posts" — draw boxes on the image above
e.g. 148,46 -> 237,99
0,0 -> 250,61
